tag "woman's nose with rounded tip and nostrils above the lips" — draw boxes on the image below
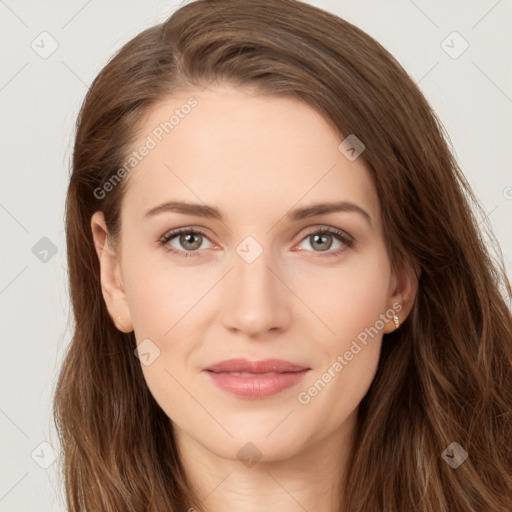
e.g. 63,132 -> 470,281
221,242 -> 293,338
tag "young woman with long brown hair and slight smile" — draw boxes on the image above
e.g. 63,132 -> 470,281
55,0 -> 512,512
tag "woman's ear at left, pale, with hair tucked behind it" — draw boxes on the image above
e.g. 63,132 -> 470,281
91,211 -> 133,333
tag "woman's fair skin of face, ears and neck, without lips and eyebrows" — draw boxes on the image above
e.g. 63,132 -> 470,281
91,84 -> 416,512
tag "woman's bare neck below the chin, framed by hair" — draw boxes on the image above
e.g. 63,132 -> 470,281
173,411 -> 356,512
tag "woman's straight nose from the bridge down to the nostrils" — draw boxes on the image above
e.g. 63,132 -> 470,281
223,236 -> 289,335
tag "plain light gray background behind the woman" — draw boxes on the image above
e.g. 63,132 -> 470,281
0,0 -> 512,512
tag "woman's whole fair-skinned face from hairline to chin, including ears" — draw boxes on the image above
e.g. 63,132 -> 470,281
92,85 -> 414,460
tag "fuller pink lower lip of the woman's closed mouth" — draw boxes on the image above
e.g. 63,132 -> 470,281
206,370 -> 309,399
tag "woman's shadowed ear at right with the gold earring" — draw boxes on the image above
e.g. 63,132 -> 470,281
384,263 -> 421,333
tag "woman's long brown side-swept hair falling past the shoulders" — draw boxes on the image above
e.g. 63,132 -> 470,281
55,0 -> 512,512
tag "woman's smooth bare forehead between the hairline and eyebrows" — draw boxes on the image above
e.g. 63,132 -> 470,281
119,86 -> 378,225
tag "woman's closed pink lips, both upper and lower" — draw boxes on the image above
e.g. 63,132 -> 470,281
204,359 -> 310,399
